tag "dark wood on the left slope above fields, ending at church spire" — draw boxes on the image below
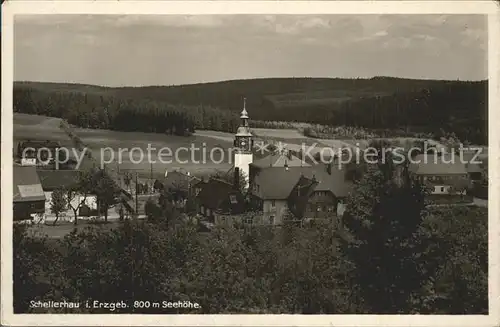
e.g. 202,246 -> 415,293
14,84 -> 239,136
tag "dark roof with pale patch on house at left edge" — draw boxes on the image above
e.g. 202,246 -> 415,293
12,165 -> 45,202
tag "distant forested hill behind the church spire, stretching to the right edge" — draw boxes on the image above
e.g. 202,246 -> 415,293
112,76 -> 488,144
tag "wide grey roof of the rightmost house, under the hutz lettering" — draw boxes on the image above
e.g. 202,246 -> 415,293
409,154 -> 467,175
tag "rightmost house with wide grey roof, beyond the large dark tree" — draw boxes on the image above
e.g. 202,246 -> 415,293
409,153 -> 471,198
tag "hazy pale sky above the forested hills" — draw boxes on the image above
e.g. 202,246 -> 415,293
14,15 -> 488,86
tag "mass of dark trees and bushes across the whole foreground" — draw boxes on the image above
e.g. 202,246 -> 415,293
14,151 -> 488,314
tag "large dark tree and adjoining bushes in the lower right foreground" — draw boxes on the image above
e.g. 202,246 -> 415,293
342,161 -> 488,314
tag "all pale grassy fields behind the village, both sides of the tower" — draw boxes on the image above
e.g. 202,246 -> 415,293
14,113 -> 452,181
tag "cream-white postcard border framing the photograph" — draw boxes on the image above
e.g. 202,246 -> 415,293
1,1 -> 500,326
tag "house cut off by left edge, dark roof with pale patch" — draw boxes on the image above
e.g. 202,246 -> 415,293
12,164 -> 45,221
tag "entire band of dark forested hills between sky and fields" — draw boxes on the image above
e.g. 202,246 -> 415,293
14,77 -> 488,144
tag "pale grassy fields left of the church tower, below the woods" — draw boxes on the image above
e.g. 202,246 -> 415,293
14,113 -> 232,178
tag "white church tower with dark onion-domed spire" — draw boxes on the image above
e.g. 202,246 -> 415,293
234,99 -> 253,188
